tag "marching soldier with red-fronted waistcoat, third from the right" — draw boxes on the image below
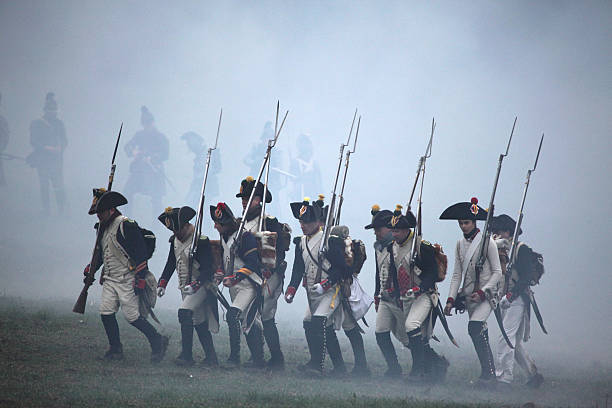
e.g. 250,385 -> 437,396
383,204 -> 448,381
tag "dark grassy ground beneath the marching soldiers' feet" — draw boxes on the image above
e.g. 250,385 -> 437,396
0,297 -> 612,408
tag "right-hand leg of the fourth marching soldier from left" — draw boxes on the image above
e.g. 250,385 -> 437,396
262,273 -> 285,370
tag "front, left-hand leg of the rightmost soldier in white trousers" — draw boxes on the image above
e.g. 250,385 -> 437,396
495,299 -> 524,384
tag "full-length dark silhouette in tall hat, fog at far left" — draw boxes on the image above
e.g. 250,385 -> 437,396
26,92 -> 68,214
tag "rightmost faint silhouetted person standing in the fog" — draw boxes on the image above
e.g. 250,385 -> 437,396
289,134 -> 321,202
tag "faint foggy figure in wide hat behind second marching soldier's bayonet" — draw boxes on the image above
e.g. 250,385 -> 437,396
181,132 -> 221,208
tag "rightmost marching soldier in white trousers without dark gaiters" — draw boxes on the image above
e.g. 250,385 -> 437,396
491,214 -> 544,388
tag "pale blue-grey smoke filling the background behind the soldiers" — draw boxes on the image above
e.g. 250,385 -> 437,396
0,1 -> 612,372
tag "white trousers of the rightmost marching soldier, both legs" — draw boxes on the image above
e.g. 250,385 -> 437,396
495,297 -> 536,383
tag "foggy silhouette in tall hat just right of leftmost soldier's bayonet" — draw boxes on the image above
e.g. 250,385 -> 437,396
124,106 -> 169,217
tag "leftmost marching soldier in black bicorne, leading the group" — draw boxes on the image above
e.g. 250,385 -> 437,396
84,188 -> 168,363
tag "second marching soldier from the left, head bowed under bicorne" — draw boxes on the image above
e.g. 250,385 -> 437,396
157,206 -> 219,366
